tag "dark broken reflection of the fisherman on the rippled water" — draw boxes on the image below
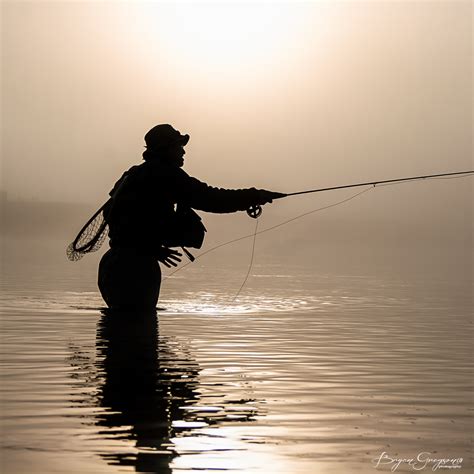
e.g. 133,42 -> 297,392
70,311 -> 258,473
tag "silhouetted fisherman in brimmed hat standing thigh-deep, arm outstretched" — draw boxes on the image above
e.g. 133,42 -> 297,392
98,124 -> 282,311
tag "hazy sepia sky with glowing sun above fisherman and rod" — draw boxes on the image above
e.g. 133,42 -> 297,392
1,1 -> 473,228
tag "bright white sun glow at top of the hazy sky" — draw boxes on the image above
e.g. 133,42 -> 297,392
131,2 -> 334,74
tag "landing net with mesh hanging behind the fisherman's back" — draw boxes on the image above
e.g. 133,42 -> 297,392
66,203 -> 108,262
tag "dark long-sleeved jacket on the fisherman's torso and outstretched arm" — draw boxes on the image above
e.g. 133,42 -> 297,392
106,160 -> 260,255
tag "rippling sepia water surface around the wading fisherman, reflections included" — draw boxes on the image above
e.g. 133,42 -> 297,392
1,239 -> 473,474
